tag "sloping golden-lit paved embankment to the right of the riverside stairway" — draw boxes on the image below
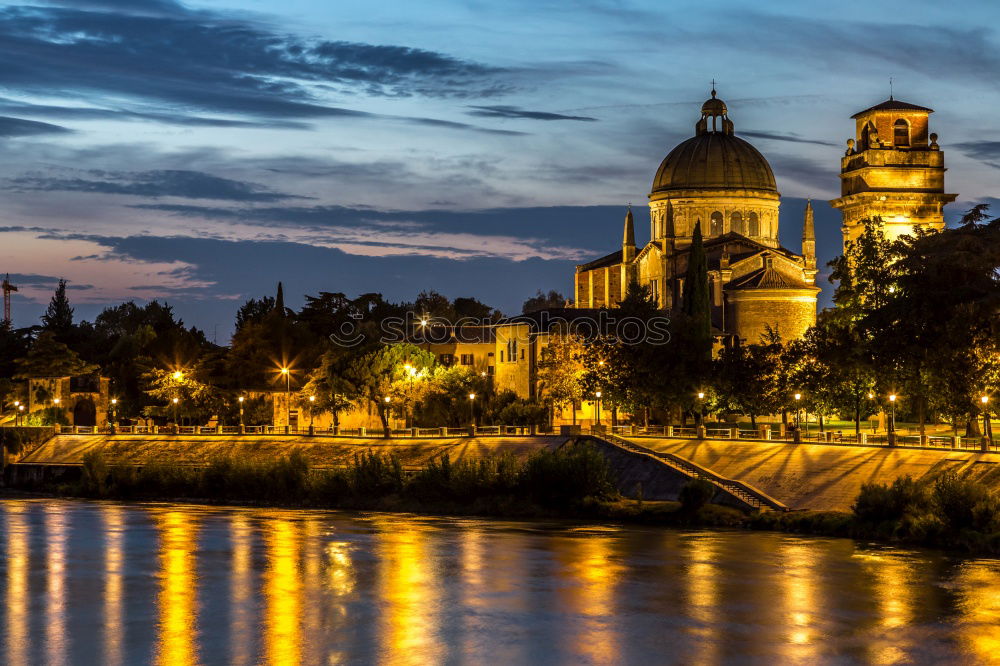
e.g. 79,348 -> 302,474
634,437 -> 1000,511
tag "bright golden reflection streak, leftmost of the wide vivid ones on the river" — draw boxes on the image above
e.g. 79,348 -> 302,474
156,510 -> 198,666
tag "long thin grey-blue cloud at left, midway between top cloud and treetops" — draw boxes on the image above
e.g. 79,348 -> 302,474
7,170 -> 305,202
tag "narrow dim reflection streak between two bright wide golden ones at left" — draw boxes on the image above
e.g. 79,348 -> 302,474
229,513 -> 255,665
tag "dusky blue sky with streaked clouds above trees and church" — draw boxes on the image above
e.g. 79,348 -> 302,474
0,0 -> 1000,334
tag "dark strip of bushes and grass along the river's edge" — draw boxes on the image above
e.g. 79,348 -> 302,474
11,445 -> 1000,555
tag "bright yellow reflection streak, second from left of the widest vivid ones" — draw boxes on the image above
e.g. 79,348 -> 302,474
263,518 -> 302,664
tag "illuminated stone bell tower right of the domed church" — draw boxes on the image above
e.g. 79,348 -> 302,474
830,96 -> 958,243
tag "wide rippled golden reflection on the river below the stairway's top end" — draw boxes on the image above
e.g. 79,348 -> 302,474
558,529 -> 622,664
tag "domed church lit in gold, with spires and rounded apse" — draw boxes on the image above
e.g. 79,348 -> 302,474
574,90 -> 820,343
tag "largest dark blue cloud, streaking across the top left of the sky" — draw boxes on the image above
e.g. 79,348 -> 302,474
0,1 -> 511,124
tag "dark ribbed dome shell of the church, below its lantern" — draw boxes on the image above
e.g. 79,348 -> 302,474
653,132 -> 778,193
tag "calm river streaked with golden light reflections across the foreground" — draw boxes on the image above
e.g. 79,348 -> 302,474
0,499 -> 1000,666
